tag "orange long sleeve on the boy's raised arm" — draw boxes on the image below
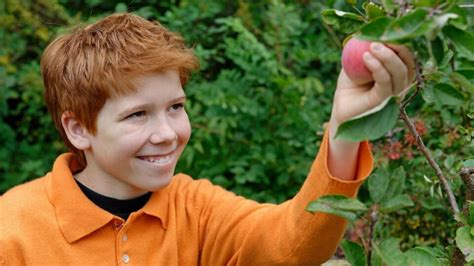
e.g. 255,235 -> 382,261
195,130 -> 373,265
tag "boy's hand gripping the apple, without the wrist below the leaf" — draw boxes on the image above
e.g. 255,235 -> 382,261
331,42 -> 415,126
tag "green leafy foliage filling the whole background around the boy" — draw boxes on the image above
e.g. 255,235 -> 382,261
0,0 -> 474,264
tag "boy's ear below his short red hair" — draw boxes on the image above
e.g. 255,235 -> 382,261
61,111 -> 91,151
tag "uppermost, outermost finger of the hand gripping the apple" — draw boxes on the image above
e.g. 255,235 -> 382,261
370,42 -> 408,95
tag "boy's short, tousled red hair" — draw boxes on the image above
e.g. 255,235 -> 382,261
41,13 -> 199,167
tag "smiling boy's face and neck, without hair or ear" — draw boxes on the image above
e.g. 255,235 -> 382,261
76,71 -> 191,199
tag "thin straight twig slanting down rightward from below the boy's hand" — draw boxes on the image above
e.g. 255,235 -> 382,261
400,108 -> 459,214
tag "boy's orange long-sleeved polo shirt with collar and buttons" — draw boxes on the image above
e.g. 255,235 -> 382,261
0,134 -> 372,265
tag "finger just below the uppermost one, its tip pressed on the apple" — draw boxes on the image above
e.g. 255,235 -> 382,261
363,52 -> 393,107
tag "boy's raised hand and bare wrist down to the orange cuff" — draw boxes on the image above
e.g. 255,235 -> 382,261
328,43 -> 415,180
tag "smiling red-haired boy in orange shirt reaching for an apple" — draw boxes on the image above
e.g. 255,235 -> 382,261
0,11 -> 413,265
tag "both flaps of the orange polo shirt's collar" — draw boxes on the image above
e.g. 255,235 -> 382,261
46,153 -> 169,243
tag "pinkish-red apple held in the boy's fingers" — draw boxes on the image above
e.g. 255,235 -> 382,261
342,38 -> 374,84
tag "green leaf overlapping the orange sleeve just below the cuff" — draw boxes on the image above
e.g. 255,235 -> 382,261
306,195 -> 367,222
